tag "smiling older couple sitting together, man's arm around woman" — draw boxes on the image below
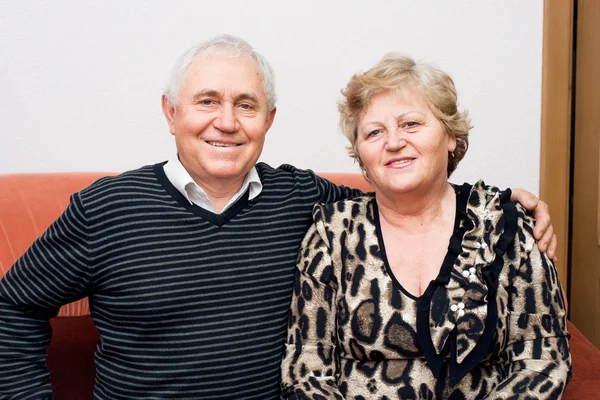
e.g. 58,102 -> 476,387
0,35 -> 570,400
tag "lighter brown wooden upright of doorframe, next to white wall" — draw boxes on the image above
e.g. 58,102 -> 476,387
540,0 -> 575,293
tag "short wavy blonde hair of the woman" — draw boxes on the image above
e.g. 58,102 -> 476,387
338,53 -> 471,176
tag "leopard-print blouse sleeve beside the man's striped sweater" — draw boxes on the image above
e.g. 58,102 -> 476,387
281,211 -> 344,400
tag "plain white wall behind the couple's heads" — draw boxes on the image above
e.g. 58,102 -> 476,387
0,0 -> 543,193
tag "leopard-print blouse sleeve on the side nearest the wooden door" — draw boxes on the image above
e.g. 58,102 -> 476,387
486,209 -> 571,399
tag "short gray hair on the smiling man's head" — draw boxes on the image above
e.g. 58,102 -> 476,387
163,35 -> 277,111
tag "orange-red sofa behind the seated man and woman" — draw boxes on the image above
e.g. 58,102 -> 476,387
0,173 -> 600,400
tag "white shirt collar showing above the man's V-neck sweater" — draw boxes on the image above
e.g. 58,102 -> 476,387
163,156 -> 262,214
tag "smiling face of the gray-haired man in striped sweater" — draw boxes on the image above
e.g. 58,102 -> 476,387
163,54 -> 275,188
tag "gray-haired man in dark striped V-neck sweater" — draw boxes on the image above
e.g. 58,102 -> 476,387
0,36 -> 553,400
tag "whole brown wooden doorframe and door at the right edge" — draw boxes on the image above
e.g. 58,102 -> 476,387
540,0 -> 600,348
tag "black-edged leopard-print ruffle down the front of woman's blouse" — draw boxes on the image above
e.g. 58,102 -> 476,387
417,181 -> 517,386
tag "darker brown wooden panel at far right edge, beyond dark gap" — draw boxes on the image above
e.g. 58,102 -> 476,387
569,0 -> 600,348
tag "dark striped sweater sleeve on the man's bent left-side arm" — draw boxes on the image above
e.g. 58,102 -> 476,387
0,195 -> 91,400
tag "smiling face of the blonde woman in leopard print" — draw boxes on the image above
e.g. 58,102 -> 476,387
357,90 -> 456,198
